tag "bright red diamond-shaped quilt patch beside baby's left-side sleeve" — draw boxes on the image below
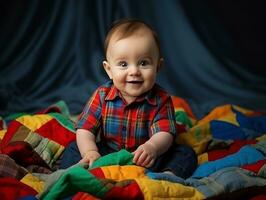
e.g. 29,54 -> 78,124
35,119 -> 76,147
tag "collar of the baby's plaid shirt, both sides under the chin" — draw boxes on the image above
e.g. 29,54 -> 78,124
105,85 -> 157,106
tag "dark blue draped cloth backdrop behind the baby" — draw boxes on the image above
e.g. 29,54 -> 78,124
0,0 -> 266,117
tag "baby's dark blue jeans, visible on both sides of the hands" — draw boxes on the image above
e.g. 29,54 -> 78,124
60,141 -> 198,179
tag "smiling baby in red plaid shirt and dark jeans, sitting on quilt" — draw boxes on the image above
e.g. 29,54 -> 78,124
62,19 -> 197,178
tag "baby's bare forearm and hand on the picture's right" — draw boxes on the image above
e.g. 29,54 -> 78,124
133,132 -> 173,167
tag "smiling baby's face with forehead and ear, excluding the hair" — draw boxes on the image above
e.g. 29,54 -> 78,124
103,29 -> 160,103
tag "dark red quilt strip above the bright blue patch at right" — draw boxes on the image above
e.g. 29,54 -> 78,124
208,140 -> 257,161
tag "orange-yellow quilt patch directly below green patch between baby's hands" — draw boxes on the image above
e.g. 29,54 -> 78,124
101,165 -> 148,181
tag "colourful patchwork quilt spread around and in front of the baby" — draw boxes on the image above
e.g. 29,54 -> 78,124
0,96 -> 266,200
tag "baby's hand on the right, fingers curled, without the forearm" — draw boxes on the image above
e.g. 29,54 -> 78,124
133,142 -> 157,167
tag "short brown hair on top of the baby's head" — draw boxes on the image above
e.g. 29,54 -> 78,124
104,18 -> 162,58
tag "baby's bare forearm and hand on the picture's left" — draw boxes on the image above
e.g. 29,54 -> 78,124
76,129 -> 101,166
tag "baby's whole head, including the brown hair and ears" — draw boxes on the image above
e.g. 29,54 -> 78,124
103,19 -> 163,103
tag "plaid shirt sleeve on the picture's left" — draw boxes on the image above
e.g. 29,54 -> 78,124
76,89 -> 102,135
